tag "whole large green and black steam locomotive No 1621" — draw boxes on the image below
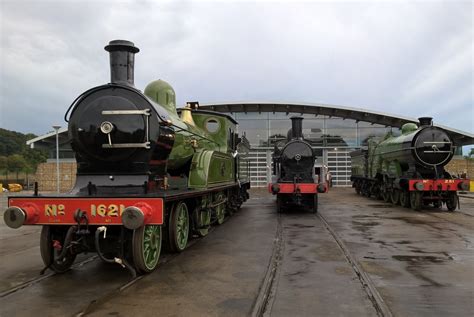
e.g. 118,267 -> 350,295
4,40 -> 250,275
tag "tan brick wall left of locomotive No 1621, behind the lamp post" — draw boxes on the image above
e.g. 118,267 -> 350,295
35,162 -> 77,193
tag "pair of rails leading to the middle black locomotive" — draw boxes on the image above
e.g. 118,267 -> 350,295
251,207 -> 392,317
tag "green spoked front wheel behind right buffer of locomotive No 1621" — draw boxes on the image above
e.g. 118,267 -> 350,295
132,225 -> 162,273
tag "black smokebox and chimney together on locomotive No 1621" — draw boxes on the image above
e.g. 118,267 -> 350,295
68,40 -> 174,174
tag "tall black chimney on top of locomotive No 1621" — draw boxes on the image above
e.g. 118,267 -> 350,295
104,40 -> 140,87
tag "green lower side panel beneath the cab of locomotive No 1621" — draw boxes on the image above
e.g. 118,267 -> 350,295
188,150 -> 234,188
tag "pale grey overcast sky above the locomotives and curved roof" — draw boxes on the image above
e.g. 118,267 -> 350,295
0,0 -> 474,138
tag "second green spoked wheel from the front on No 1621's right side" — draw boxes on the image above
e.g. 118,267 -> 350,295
168,201 -> 189,252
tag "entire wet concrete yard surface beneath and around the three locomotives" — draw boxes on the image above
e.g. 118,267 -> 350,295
0,189 -> 474,316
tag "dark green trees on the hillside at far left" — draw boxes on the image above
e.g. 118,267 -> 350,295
0,128 -> 48,174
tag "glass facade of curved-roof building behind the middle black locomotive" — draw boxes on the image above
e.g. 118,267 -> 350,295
230,112 -> 399,187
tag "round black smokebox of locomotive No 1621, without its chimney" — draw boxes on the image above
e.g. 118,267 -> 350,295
69,84 -> 174,174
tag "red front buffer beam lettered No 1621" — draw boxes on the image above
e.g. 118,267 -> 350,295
8,197 -> 164,225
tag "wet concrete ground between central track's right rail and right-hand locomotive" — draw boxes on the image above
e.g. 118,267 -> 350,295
323,189 -> 474,316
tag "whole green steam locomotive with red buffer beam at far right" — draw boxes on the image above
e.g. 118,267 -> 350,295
351,117 -> 469,211
